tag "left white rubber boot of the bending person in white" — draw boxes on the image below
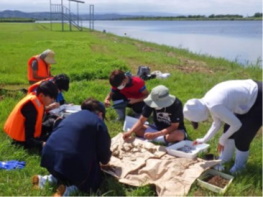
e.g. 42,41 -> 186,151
214,139 -> 235,171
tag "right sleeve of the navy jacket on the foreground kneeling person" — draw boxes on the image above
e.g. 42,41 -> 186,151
97,122 -> 111,164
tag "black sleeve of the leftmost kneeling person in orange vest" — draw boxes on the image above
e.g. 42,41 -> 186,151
21,101 -> 43,148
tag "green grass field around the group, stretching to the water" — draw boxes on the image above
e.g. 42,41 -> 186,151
0,23 -> 262,196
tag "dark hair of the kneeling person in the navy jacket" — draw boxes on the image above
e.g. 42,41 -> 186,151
81,98 -> 106,119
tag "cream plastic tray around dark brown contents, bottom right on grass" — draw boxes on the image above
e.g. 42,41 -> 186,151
197,169 -> 234,194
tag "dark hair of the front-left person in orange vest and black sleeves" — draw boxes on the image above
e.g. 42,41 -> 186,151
36,81 -> 58,99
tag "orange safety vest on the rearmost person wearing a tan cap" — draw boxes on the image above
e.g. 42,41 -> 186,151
27,55 -> 50,82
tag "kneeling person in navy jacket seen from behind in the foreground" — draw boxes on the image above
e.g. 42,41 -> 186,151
33,98 -> 111,196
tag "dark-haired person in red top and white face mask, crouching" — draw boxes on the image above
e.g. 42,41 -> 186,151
104,70 -> 149,120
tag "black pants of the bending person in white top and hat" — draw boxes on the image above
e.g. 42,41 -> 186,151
224,81 -> 262,151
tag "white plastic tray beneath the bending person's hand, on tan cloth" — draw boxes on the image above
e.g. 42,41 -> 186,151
166,140 -> 209,159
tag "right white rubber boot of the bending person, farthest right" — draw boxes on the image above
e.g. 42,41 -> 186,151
230,149 -> 249,174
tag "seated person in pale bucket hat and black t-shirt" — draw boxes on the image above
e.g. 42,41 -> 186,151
123,85 -> 187,143
